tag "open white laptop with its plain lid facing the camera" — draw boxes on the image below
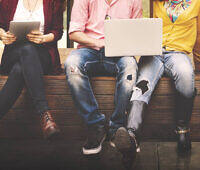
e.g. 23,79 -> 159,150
104,18 -> 162,57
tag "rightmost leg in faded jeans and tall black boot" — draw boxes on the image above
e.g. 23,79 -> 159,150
166,52 -> 195,151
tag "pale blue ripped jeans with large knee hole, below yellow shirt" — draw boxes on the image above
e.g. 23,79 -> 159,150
131,50 -> 195,104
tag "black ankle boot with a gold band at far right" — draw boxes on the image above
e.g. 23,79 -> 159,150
175,127 -> 192,152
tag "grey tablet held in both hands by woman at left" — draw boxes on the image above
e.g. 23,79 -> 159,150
9,21 -> 40,41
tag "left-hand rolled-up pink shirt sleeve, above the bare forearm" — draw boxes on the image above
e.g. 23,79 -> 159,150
69,0 -> 89,34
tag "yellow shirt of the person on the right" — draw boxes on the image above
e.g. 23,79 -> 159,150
153,0 -> 200,53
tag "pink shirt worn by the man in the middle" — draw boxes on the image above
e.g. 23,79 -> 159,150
69,0 -> 142,48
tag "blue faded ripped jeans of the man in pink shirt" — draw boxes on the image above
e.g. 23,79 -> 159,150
65,48 -> 137,129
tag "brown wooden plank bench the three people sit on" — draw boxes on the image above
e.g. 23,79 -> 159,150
0,49 -> 200,141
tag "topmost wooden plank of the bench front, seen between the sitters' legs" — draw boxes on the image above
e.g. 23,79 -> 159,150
0,74 -> 200,96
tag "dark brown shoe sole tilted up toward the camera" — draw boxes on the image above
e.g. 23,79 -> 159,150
113,127 -> 134,153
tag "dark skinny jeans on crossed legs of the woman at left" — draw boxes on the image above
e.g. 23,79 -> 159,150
0,42 -> 52,118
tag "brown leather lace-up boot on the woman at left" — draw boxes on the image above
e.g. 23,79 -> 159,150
41,111 -> 60,139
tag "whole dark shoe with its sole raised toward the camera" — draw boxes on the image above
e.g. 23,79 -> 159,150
110,127 -> 139,154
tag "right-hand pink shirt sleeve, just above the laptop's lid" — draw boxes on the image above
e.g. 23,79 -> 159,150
131,0 -> 143,19
